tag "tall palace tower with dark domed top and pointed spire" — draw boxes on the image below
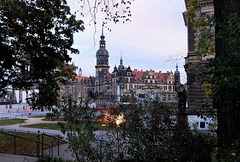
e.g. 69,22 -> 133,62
95,27 -> 109,80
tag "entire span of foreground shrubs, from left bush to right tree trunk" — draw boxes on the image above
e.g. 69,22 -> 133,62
61,98 -> 216,161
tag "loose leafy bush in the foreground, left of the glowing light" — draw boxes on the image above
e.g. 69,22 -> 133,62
59,97 -> 97,161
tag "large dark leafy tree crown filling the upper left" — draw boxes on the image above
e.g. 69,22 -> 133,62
0,0 -> 84,108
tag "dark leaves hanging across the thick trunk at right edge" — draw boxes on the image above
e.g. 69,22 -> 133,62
209,14 -> 240,106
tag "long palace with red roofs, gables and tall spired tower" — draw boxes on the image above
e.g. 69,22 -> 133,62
60,30 -> 180,102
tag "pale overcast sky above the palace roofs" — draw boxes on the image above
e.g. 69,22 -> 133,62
68,0 -> 187,83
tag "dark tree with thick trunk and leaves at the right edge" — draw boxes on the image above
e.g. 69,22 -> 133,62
213,0 -> 240,152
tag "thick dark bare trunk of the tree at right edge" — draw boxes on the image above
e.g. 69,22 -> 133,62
214,0 -> 240,149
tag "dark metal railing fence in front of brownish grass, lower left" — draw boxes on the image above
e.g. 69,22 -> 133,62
0,129 -> 67,158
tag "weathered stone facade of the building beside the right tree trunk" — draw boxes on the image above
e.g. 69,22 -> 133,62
183,0 -> 214,111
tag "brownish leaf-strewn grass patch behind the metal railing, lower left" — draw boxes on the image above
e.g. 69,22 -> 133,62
0,130 -> 63,156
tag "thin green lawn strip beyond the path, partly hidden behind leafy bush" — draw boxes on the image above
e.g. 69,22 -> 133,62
23,123 -> 108,130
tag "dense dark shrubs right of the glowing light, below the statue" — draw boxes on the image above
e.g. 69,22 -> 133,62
106,104 -> 216,161
